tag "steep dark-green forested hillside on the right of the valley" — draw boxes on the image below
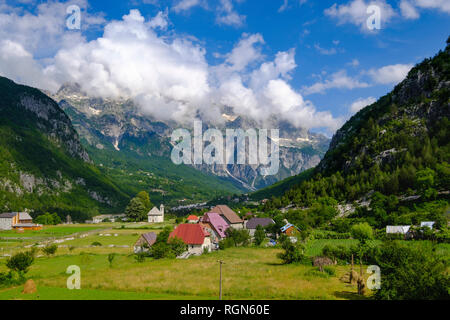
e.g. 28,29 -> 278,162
265,41 -> 450,227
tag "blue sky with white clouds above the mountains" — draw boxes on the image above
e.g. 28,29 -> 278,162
0,0 -> 450,136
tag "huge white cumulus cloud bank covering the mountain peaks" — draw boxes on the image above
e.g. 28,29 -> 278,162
0,10 -> 342,130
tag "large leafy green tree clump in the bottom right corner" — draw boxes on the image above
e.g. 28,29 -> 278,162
375,241 -> 450,300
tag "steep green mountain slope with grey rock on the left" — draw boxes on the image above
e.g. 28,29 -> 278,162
0,78 -> 127,218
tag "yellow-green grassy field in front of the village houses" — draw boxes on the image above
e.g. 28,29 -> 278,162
0,224 -> 450,300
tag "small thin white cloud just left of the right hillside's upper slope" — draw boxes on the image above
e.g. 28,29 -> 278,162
303,70 -> 369,95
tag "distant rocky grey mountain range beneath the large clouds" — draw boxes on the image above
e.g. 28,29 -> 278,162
51,84 -> 330,192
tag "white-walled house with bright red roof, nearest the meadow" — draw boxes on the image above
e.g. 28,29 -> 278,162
169,223 -> 211,255
